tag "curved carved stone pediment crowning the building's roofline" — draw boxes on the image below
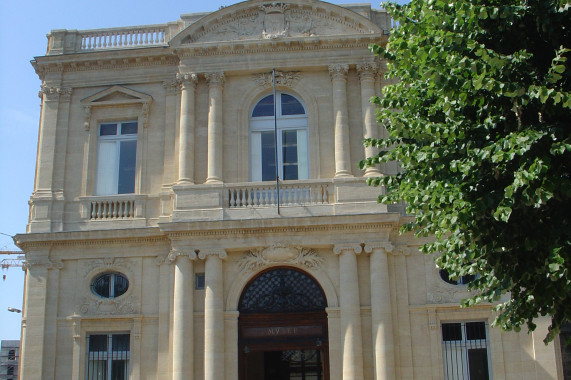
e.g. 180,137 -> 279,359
169,0 -> 382,47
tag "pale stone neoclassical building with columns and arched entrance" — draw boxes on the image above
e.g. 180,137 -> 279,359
16,0 -> 562,380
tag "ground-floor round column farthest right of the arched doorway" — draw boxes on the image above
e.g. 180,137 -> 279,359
365,242 -> 395,380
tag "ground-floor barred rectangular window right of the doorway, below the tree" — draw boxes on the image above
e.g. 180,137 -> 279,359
442,322 -> 491,380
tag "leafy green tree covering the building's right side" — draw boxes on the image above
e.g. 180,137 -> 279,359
361,0 -> 571,343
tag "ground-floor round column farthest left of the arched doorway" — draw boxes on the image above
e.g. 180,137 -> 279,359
167,251 -> 196,380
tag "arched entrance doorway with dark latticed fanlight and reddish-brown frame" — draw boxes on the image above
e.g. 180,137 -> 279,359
238,268 -> 329,380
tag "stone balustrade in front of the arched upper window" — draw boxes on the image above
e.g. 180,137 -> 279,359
226,180 -> 331,208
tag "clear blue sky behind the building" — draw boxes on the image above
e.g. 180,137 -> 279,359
0,0 -> 402,339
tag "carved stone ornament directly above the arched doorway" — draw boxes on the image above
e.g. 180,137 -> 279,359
239,242 -> 325,272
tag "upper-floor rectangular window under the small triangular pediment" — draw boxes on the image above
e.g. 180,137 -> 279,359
95,121 -> 137,195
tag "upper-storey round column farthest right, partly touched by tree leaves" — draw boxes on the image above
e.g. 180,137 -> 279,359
357,63 -> 381,177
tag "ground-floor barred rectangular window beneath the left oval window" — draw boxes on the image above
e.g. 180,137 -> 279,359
87,334 -> 130,380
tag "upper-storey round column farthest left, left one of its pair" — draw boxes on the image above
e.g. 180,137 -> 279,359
177,73 -> 199,183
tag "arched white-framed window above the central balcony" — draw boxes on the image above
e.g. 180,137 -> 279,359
250,92 -> 309,181
